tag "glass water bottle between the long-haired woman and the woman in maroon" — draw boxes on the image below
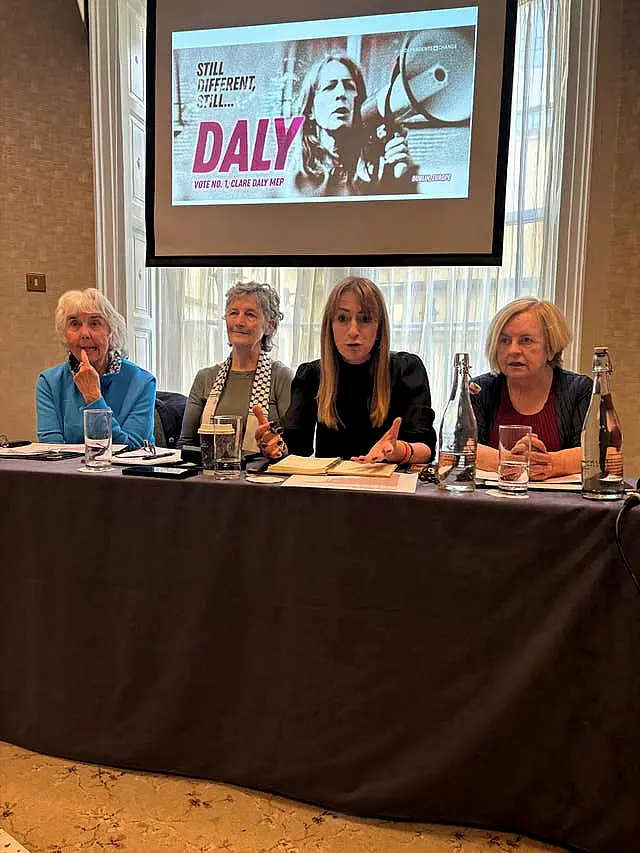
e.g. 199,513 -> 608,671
438,352 -> 478,492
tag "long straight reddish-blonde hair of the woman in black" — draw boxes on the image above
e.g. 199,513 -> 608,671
318,276 -> 391,429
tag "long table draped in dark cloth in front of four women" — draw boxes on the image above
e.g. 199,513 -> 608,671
0,460 -> 640,853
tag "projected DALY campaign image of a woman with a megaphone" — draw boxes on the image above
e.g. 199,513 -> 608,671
172,7 -> 477,205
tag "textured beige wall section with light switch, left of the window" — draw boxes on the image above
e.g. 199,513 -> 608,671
0,0 -> 95,438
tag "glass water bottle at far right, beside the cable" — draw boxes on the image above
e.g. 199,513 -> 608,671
580,347 -> 624,501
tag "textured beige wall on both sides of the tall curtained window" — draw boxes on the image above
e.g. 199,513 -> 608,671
0,0 -> 640,475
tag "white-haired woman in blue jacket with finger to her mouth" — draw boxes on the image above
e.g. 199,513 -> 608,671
36,287 -> 156,449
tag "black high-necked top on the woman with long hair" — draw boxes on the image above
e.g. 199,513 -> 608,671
283,352 -> 436,459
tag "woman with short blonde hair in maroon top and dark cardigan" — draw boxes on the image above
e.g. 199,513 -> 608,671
472,296 -> 592,480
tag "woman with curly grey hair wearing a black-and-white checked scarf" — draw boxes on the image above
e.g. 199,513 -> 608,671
178,281 -> 291,453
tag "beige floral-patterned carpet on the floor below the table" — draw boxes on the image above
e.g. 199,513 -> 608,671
0,743 -> 560,853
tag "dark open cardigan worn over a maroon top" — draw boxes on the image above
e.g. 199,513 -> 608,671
471,367 -> 593,450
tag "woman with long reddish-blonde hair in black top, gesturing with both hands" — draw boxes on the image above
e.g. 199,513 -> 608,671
256,277 -> 436,463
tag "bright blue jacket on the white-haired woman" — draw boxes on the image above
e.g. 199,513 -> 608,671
36,358 -> 156,449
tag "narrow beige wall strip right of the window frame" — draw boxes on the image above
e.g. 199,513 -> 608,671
581,0 -> 640,477
